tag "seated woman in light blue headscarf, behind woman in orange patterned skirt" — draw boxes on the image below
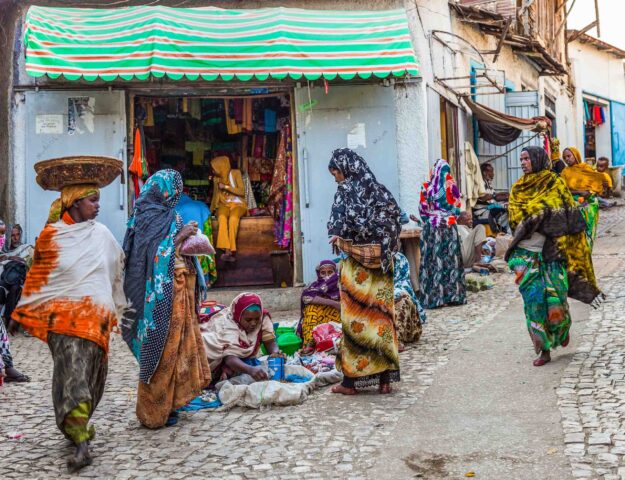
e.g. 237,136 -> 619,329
394,252 -> 425,350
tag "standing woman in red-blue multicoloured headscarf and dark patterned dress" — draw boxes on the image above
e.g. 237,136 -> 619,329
412,159 -> 467,308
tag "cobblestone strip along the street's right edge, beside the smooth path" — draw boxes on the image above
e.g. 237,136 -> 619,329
556,204 -> 625,480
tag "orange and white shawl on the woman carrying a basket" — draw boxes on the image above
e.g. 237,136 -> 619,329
13,215 -> 128,352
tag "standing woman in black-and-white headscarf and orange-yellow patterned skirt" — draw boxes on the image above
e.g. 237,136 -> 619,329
328,149 -> 401,395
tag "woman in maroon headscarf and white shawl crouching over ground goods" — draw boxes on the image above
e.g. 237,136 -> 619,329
201,293 -> 282,382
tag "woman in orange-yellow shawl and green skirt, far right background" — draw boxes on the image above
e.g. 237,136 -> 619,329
560,147 -> 604,251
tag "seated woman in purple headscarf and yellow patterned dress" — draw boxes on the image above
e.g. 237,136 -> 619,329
297,260 -> 341,350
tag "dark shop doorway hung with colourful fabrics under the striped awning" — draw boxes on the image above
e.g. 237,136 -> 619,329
129,92 -> 294,287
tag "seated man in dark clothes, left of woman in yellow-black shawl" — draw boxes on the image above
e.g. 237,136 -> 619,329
473,163 -> 510,233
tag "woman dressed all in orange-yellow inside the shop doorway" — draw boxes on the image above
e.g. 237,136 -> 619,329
211,156 -> 247,262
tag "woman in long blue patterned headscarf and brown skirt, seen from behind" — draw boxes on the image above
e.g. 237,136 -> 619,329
122,170 -> 211,428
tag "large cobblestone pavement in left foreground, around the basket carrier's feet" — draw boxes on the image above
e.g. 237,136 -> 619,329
0,208 -> 625,479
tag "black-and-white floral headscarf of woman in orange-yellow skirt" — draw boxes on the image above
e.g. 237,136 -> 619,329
328,148 -> 401,272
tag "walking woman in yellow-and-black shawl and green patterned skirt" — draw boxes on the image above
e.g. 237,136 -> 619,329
506,147 -> 604,367
